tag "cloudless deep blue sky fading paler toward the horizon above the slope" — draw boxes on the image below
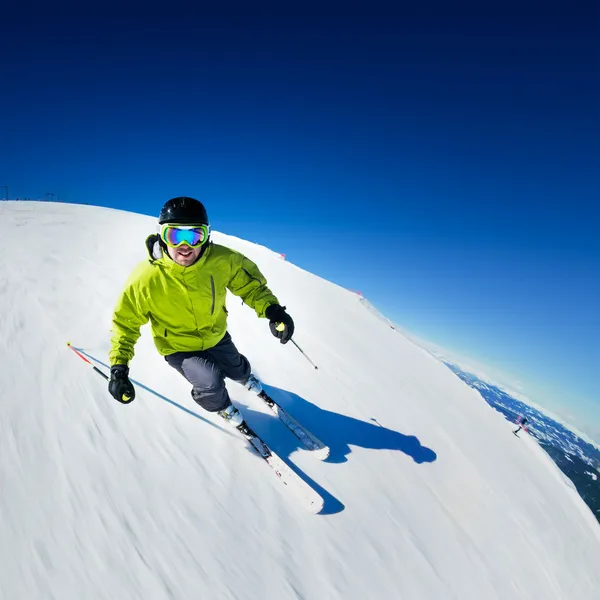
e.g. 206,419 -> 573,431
0,2 -> 600,437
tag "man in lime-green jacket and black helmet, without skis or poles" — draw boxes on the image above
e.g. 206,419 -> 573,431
108,197 -> 294,434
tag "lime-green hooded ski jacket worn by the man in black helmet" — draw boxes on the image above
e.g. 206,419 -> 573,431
109,236 -> 279,365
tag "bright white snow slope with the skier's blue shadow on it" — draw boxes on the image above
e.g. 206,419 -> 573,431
0,202 -> 600,600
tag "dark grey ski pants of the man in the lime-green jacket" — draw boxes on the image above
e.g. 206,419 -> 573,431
165,333 -> 250,412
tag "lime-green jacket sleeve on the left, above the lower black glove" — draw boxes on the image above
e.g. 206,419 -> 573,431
108,272 -> 149,366
